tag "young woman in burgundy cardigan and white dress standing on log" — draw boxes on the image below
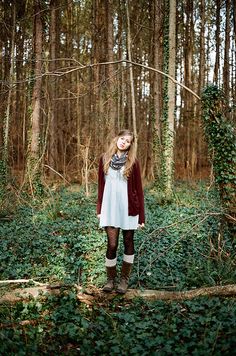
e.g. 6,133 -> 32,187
97,130 -> 145,294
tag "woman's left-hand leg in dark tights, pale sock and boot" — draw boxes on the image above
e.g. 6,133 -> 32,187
103,226 -> 120,292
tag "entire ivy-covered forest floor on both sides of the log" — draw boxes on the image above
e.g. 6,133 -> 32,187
0,183 -> 236,355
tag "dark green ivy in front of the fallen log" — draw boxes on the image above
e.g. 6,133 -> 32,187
0,290 -> 236,355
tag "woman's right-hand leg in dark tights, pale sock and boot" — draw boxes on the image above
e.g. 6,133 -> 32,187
117,230 -> 134,294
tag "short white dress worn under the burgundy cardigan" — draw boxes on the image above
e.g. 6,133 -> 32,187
100,167 -> 139,230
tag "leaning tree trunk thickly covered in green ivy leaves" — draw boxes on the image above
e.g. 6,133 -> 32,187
202,85 -> 236,221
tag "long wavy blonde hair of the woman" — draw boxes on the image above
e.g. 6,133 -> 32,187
103,129 -> 137,178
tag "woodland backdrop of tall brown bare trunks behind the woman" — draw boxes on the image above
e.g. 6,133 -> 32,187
0,0 -> 236,191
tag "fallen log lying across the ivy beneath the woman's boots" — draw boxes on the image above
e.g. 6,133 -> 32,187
0,284 -> 236,305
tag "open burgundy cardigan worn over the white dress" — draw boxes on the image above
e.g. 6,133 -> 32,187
97,157 -> 145,224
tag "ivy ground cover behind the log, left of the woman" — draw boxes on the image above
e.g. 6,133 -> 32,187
0,191 -> 105,282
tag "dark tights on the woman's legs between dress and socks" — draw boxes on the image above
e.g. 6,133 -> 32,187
105,226 -> 134,260
